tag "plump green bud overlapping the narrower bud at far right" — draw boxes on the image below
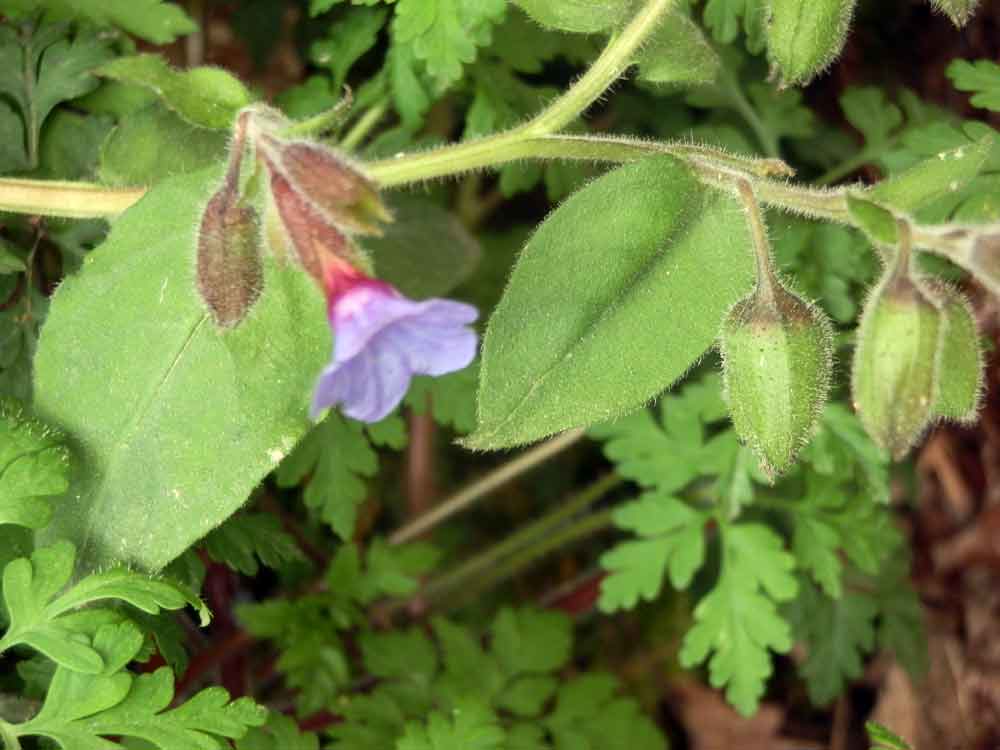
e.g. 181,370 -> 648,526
852,258 -> 942,459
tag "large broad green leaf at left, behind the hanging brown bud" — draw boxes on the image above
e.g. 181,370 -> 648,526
35,168 -> 330,570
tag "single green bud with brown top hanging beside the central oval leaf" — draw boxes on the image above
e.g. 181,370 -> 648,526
719,277 -> 833,477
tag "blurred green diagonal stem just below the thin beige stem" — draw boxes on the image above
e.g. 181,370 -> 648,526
421,474 -> 625,601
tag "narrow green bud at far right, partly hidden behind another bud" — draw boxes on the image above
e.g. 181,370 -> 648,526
933,285 -> 985,423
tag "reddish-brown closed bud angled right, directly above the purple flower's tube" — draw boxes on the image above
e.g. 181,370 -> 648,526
259,134 -> 392,235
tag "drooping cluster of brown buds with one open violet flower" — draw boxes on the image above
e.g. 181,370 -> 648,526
198,110 -> 478,422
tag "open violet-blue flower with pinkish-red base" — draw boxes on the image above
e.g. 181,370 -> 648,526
311,272 -> 479,422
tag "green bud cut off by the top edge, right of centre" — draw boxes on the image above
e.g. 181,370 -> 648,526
767,0 -> 856,85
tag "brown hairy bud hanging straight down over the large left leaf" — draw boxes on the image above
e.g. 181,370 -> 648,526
197,180 -> 263,328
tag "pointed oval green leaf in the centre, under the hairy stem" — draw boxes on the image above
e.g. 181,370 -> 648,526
466,156 -> 753,449
